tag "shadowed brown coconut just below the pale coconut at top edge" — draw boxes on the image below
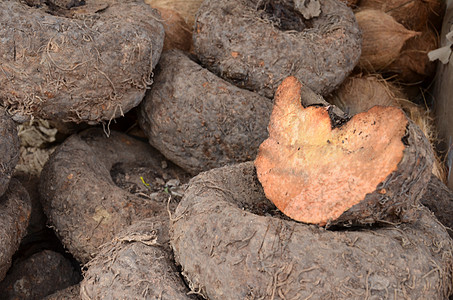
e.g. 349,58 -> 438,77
150,7 -> 192,51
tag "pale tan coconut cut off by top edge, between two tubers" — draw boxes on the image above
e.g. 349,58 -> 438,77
145,0 -> 203,29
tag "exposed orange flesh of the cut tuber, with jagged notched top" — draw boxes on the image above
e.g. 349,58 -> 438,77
255,77 -> 408,226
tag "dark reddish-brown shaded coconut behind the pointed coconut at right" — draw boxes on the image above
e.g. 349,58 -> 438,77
388,26 -> 439,83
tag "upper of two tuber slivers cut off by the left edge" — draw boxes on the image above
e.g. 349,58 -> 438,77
0,108 -> 20,196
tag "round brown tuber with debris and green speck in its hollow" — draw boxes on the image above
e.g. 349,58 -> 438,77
40,129 -> 186,263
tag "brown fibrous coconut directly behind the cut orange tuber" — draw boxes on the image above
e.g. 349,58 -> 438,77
327,75 -> 398,115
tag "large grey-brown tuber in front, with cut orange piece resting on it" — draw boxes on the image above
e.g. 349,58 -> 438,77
170,162 -> 453,300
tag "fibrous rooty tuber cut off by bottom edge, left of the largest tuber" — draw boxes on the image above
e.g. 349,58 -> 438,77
80,216 -> 196,300
